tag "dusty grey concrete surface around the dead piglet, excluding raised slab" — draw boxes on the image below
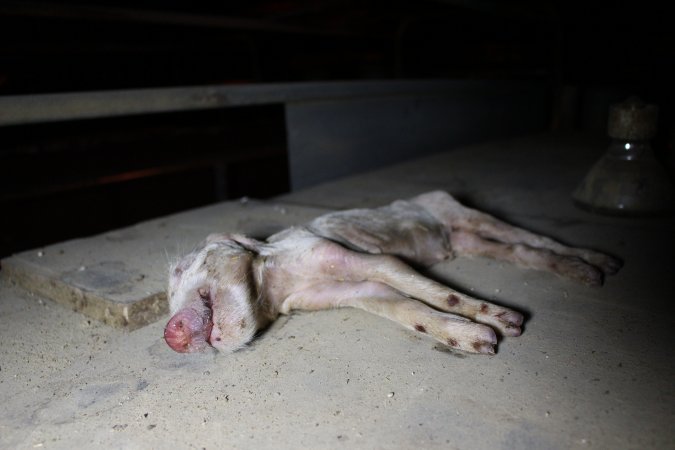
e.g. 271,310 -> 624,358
0,136 -> 675,449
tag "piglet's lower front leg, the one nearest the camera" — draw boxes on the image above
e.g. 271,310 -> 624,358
281,281 -> 497,355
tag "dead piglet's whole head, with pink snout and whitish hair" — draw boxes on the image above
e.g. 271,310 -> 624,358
164,235 -> 261,353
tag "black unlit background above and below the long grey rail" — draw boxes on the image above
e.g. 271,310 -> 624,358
0,0 -> 675,256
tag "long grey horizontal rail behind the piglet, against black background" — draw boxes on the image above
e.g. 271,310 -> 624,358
0,80 -> 526,126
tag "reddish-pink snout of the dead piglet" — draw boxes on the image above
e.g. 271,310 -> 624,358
164,308 -> 213,353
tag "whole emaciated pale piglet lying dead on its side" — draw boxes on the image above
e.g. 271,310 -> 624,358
164,191 -> 621,354
